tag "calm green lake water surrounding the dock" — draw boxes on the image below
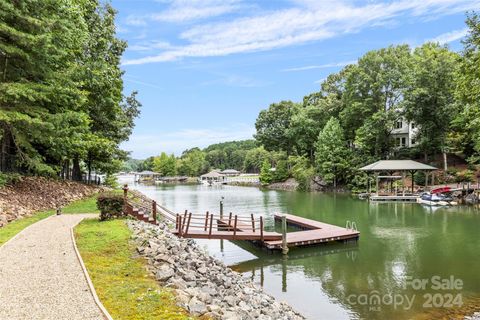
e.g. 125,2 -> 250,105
121,180 -> 480,319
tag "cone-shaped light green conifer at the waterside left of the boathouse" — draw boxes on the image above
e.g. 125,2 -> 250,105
315,117 -> 350,188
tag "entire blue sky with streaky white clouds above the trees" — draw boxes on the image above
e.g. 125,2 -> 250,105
111,0 -> 480,159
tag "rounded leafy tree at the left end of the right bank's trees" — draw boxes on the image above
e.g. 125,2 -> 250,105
255,101 -> 299,153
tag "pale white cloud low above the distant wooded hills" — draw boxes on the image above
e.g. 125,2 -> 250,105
122,124 -> 255,158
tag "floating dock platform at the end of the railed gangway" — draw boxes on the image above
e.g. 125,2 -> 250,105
264,214 -> 360,250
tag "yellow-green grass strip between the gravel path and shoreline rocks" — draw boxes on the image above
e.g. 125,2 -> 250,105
75,219 -> 192,320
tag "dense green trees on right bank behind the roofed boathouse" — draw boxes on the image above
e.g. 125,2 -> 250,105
255,12 -> 480,189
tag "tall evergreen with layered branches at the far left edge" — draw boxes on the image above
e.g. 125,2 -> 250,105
0,0 -> 89,174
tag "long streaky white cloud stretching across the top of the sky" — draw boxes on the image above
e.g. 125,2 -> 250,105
124,0 -> 479,65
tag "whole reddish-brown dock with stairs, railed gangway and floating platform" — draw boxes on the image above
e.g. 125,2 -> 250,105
124,187 -> 360,253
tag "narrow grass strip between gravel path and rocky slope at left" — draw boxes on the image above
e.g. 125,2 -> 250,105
0,195 -> 98,246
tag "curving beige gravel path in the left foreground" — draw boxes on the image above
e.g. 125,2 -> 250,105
0,214 -> 104,320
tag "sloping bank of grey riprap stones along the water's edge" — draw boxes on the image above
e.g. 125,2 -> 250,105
127,220 -> 305,320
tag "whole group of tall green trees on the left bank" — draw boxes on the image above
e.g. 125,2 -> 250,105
0,0 -> 141,180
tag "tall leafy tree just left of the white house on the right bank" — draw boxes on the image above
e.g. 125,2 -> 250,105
339,45 -> 411,158
